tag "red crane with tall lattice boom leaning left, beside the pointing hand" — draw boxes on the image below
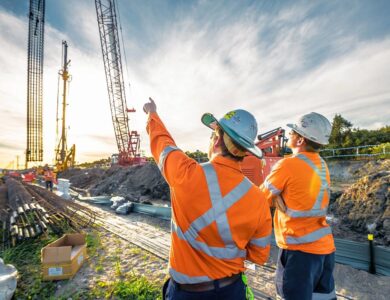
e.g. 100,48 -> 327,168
95,0 -> 146,165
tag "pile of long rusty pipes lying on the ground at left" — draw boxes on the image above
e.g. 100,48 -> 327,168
0,178 -> 96,248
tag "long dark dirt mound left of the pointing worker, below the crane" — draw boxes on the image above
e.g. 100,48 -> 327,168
61,163 -> 170,203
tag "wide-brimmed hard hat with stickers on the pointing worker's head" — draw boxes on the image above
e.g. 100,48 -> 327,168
202,109 -> 262,158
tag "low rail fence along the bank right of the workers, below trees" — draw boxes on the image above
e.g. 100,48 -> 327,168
320,143 -> 390,158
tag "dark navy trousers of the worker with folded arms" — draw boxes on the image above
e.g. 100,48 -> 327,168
275,249 -> 336,300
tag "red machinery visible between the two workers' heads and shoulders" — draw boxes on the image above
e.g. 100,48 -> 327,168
241,127 -> 287,186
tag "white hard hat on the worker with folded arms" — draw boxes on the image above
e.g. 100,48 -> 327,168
287,112 -> 332,145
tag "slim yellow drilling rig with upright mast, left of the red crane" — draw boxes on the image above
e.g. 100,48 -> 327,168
55,41 -> 76,172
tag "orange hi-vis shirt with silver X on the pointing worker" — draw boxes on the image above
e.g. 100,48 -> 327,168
147,113 -> 272,283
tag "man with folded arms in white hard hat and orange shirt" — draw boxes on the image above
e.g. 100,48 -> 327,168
261,112 -> 336,300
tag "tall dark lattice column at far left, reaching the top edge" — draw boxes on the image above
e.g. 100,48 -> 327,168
25,0 -> 45,169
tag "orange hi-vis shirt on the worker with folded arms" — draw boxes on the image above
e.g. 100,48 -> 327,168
260,152 -> 336,254
